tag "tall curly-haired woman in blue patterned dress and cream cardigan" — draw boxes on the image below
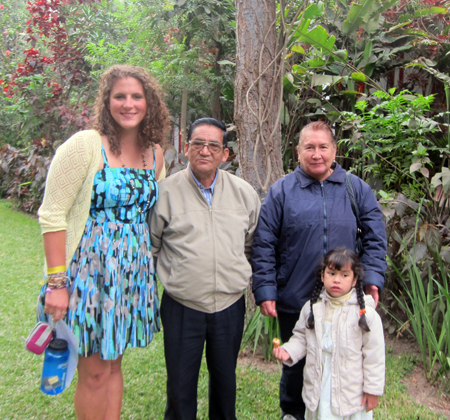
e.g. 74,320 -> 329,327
39,65 -> 169,420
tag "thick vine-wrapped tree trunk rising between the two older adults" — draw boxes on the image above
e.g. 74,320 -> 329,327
234,0 -> 284,197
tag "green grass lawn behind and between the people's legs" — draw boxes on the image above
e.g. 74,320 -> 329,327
0,200 -> 442,420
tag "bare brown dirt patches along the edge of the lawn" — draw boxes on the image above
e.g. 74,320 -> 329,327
238,336 -> 450,420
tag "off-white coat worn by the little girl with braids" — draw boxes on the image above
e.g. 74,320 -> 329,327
282,289 -> 385,417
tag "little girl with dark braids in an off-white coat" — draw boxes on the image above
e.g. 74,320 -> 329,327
273,248 -> 385,420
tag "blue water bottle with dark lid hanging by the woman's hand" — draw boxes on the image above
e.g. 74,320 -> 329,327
41,338 -> 69,395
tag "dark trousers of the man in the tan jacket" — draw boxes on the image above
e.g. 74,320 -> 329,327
161,292 -> 245,420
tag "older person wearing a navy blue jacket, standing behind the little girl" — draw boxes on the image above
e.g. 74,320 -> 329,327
252,121 -> 387,420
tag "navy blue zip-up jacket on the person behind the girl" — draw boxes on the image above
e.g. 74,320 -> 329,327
252,164 -> 387,313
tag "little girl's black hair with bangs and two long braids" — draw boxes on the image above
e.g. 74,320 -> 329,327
306,247 -> 370,332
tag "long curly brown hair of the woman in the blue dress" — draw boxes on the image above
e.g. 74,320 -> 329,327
91,64 -> 169,155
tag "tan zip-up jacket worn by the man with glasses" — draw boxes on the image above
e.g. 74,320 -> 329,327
150,167 -> 261,313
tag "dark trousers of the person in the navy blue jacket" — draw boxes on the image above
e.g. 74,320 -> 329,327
278,311 -> 306,419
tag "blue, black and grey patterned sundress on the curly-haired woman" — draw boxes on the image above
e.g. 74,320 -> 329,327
38,146 -> 160,360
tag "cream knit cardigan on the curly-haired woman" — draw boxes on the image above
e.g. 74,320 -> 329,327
38,130 -> 102,267
